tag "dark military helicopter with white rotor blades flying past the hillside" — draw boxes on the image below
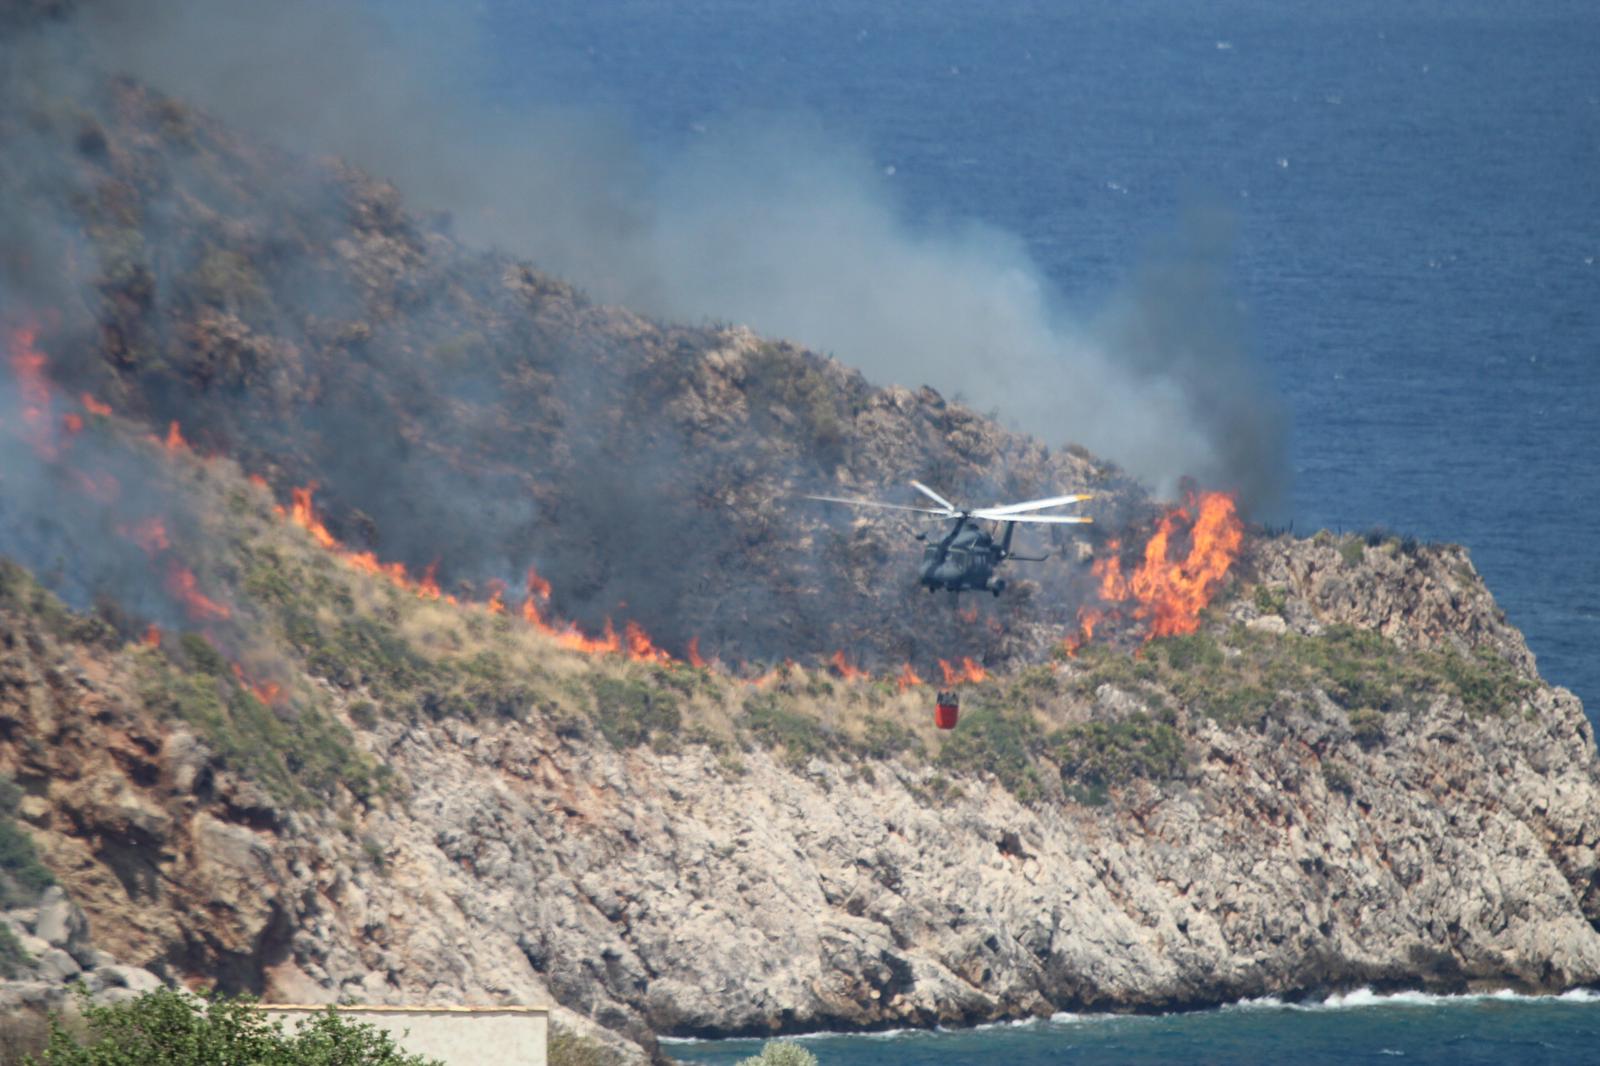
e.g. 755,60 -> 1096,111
805,480 -> 1094,599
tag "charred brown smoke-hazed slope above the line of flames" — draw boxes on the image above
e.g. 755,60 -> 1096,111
5,70 -> 1177,672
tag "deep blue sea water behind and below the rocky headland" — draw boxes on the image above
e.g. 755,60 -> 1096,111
457,0 -> 1600,1066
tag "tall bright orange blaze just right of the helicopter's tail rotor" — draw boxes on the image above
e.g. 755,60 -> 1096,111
1064,493 -> 1245,655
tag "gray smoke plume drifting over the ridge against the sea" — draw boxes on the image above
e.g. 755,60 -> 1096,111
53,0 -> 1285,509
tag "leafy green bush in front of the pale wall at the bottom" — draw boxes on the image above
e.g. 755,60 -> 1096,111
27,988 -> 437,1066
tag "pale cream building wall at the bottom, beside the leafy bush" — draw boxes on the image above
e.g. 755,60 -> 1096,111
261,1004 -> 550,1066
